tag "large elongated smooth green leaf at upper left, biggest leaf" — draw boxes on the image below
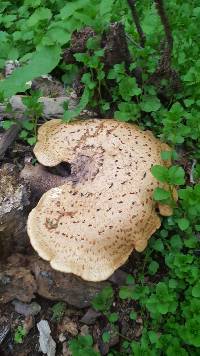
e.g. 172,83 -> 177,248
0,46 -> 61,97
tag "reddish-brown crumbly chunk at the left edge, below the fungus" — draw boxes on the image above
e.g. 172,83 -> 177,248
0,266 -> 37,303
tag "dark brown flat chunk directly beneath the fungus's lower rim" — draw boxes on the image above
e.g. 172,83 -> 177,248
29,256 -> 108,308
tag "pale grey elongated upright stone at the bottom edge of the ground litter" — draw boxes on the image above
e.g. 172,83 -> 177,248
37,320 -> 56,356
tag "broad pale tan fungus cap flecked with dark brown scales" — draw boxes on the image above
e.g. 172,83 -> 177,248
28,119 -> 170,281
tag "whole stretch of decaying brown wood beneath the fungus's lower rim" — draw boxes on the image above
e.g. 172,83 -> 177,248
0,254 -> 127,308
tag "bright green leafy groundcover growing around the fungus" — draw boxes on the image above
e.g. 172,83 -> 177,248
0,0 -> 200,356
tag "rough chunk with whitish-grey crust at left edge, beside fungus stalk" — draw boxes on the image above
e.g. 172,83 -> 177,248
0,164 -> 30,259
